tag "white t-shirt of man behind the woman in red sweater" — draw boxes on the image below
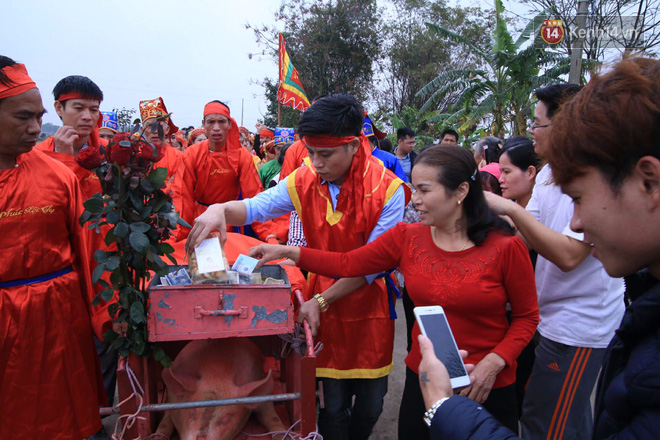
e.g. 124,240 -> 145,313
527,165 -> 624,348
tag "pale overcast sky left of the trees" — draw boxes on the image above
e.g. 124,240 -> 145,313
0,0 -> 280,131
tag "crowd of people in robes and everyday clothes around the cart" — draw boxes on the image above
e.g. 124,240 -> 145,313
0,57 -> 660,440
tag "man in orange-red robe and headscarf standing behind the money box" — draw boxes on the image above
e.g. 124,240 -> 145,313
174,101 -> 278,240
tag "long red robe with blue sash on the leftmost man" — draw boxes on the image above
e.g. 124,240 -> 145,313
0,151 -> 107,440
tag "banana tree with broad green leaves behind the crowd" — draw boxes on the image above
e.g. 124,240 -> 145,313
417,0 -> 570,138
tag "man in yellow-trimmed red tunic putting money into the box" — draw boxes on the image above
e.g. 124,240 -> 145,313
187,94 -> 406,439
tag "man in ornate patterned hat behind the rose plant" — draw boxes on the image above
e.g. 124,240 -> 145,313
140,97 -> 183,192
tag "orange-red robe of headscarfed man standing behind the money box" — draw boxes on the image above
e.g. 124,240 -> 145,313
173,140 -> 270,240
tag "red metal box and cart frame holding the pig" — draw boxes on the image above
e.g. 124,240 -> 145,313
102,265 -> 316,439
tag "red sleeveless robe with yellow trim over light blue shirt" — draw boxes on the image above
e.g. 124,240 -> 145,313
287,152 -> 403,379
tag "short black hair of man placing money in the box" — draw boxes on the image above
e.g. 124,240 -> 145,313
298,93 -> 364,137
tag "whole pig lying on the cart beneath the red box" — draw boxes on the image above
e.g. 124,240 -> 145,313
156,338 -> 286,440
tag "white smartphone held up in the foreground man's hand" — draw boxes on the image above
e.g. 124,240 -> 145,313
415,306 -> 470,388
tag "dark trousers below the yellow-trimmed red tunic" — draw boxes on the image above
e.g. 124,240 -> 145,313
319,376 -> 388,440
